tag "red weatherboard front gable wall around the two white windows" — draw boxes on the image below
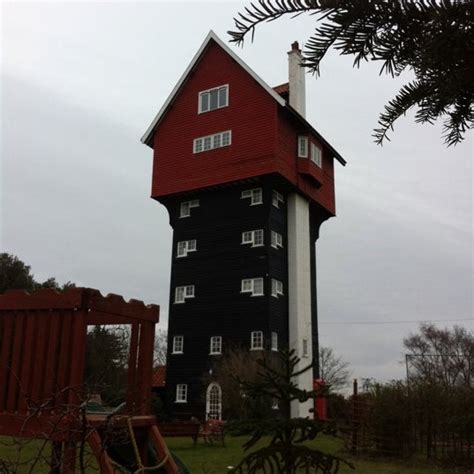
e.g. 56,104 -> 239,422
152,43 -> 278,201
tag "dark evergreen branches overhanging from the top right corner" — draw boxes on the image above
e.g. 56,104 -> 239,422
229,0 -> 474,145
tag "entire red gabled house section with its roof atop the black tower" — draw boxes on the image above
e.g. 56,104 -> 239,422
142,32 -> 345,213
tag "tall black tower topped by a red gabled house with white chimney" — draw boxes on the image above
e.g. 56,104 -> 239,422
142,32 -> 345,418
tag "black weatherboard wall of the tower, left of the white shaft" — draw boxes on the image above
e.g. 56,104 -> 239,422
162,179 -> 288,418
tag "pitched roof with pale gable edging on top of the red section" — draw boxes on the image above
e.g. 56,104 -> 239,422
141,30 -> 346,165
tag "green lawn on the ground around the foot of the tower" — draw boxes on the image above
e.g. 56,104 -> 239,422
0,436 -> 467,474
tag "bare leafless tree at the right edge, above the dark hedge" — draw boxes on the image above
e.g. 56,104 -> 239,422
403,324 -> 474,387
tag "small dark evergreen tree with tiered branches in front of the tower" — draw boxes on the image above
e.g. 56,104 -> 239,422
230,351 -> 352,474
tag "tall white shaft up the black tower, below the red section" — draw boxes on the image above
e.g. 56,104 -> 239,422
288,193 -> 314,418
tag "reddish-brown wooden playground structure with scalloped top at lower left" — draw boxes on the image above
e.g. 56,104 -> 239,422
0,288 -> 179,474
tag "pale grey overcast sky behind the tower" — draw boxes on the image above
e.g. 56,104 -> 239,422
0,2 -> 474,386
